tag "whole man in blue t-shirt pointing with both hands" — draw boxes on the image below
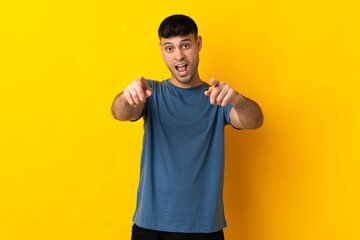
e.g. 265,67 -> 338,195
112,15 -> 263,240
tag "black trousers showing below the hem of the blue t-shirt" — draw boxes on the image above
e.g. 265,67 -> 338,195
131,223 -> 224,240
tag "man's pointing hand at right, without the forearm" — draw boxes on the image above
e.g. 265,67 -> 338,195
204,78 -> 241,107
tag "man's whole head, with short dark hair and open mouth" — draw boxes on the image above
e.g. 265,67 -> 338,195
158,15 -> 202,86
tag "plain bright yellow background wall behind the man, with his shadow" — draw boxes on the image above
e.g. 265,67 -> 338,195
0,0 -> 360,240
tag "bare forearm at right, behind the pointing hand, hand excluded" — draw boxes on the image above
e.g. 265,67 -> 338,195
233,93 -> 263,129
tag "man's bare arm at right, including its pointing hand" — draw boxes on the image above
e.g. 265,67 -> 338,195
204,78 -> 264,129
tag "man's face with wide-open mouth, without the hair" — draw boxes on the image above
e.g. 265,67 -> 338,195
159,33 -> 202,84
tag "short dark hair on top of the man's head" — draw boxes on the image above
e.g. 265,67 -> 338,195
158,14 -> 198,39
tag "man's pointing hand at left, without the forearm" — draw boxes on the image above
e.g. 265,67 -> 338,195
124,76 -> 152,107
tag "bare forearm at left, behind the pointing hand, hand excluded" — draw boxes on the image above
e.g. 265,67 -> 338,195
111,92 -> 144,121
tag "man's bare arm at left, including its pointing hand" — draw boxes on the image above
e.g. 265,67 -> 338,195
111,76 -> 152,121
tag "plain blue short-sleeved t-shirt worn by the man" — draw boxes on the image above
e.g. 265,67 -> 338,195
133,79 -> 239,233
